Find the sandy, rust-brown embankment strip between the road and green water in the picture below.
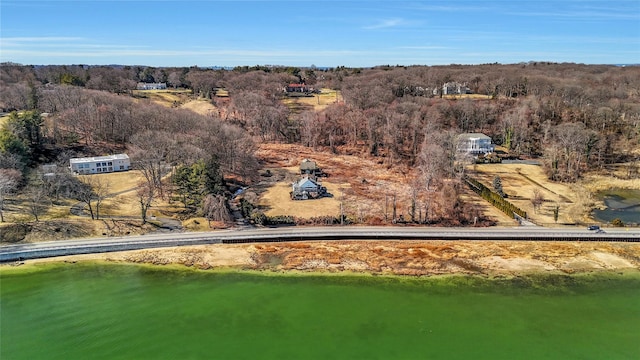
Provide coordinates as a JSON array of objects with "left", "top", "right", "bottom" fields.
[{"left": 15, "top": 241, "right": 640, "bottom": 276}]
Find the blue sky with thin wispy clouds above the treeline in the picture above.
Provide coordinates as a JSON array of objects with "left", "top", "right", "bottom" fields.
[{"left": 0, "top": 0, "right": 640, "bottom": 67}]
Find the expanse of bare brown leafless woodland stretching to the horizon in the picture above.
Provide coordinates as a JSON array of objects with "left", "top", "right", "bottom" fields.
[{"left": 0, "top": 62, "right": 640, "bottom": 226}]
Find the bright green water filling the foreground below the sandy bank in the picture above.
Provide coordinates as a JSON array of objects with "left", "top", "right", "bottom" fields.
[{"left": 0, "top": 263, "right": 640, "bottom": 360}]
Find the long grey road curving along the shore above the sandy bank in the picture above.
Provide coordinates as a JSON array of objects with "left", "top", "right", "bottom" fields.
[{"left": 0, "top": 226, "right": 640, "bottom": 262}]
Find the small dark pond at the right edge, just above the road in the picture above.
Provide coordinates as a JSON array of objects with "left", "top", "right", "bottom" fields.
[{"left": 593, "top": 189, "right": 640, "bottom": 224}]
